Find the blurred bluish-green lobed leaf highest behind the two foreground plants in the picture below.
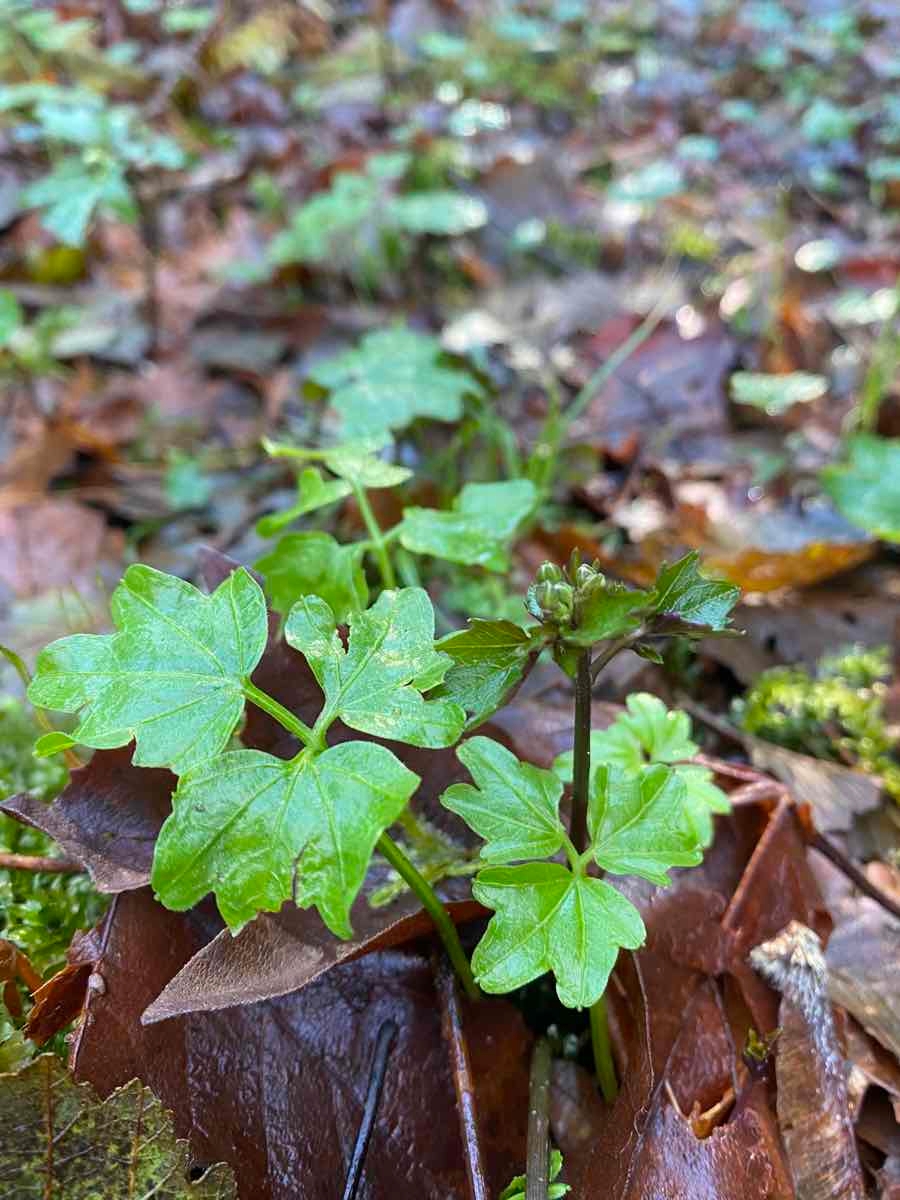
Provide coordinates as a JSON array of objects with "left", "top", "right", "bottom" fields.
[{"left": 310, "top": 329, "right": 481, "bottom": 437}]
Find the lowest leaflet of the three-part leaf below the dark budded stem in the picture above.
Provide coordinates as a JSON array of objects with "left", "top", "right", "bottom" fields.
[{"left": 472, "top": 863, "right": 646, "bottom": 1008}]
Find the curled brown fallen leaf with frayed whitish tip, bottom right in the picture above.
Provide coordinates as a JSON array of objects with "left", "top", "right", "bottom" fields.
[{"left": 750, "top": 920, "right": 865, "bottom": 1200}]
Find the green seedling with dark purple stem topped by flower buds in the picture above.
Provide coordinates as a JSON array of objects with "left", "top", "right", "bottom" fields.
[{"left": 440, "top": 553, "right": 739, "bottom": 1098}]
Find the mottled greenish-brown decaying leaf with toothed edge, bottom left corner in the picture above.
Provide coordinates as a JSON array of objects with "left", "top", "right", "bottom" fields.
[{"left": 0, "top": 1055, "right": 238, "bottom": 1200}]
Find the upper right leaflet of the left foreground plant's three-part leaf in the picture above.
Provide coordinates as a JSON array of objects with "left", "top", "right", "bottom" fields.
[{"left": 284, "top": 588, "right": 466, "bottom": 748}]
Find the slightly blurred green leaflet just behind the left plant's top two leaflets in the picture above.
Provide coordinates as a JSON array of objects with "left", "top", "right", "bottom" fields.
[{"left": 254, "top": 530, "right": 368, "bottom": 622}]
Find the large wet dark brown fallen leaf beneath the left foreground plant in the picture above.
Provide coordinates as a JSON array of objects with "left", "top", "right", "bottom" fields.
[{"left": 73, "top": 889, "right": 530, "bottom": 1200}]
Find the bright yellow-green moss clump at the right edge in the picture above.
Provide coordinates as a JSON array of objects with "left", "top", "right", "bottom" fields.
[{"left": 736, "top": 646, "right": 900, "bottom": 799}]
